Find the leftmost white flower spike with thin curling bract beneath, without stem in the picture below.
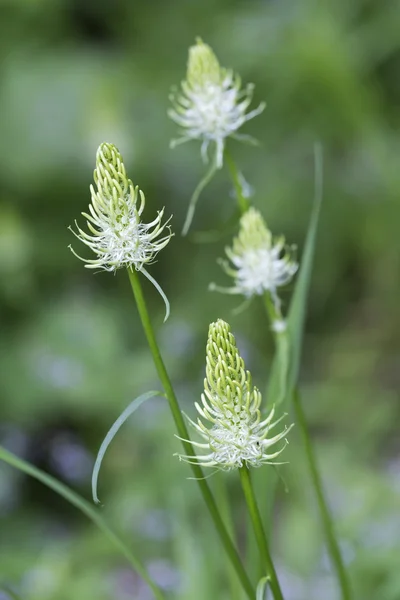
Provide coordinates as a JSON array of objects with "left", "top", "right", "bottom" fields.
[{"left": 69, "top": 143, "right": 173, "bottom": 318}]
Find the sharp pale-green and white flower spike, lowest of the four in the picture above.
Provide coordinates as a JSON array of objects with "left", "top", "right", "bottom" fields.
[{"left": 179, "top": 320, "right": 292, "bottom": 470}]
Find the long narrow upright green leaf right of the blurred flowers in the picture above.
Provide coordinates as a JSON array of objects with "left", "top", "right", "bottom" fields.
[{"left": 267, "top": 144, "right": 323, "bottom": 405}]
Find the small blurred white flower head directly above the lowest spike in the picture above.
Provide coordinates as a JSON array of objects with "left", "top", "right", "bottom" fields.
[{"left": 210, "top": 208, "right": 298, "bottom": 309}]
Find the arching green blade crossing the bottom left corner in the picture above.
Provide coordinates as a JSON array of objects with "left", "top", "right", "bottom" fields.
[{"left": 0, "top": 446, "right": 165, "bottom": 600}]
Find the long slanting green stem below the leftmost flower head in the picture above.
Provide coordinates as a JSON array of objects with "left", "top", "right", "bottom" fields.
[{"left": 128, "top": 269, "right": 255, "bottom": 600}]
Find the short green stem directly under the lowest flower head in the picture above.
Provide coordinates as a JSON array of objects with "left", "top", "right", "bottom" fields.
[{"left": 239, "top": 466, "right": 284, "bottom": 600}]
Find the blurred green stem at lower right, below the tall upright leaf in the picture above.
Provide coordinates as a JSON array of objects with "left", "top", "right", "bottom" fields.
[{"left": 293, "top": 390, "right": 351, "bottom": 600}]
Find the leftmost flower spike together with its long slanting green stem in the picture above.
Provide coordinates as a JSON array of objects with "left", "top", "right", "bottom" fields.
[{"left": 73, "top": 144, "right": 255, "bottom": 600}]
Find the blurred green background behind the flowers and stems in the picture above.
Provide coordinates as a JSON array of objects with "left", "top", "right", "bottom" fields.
[{"left": 0, "top": 0, "right": 400, "bottom": 600}]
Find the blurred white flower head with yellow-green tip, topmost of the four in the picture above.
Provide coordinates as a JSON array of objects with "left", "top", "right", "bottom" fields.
[{"left": 168, "top": 38, "right": 265, "bottom": 168}]
